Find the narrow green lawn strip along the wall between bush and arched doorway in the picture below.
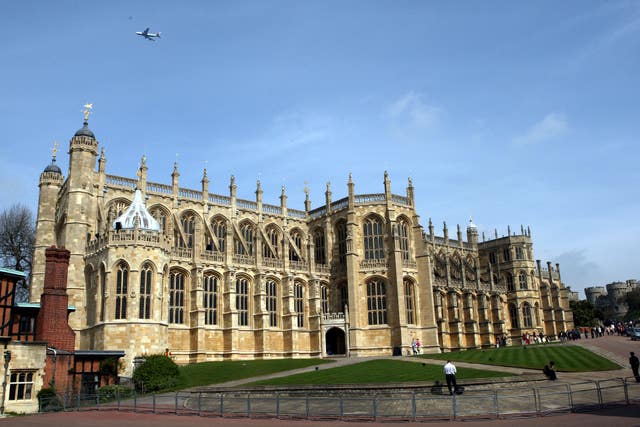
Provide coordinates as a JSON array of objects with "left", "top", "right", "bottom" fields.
[{"left": 176, "top": 359, "right": 333, "bottom": 389}]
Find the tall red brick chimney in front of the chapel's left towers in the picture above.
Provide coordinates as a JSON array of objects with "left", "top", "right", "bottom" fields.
[{"left": 35, "top": 246, "right": 76, "bottom": 351}]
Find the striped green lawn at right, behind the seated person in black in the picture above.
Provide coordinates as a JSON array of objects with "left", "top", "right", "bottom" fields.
[{"left": 420, "top": 344, "right": 620, "bottom": 372}]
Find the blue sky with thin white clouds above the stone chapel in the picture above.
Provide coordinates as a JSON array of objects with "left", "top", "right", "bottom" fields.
[{"left": 0, "top": 0, "right": 640, "bottom": 296}]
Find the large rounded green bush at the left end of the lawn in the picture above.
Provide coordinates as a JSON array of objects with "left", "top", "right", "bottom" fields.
[{"left": 133, "top": 354, "right": 180, "bottom": 392}]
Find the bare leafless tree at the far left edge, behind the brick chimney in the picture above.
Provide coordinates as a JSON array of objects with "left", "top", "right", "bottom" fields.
[{"left": 0, "top": 204, "right": 36, "bottom": 300}]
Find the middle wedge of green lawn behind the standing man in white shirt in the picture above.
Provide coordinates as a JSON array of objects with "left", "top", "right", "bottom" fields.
[{"left": 251, "top": 359, "right": 511, "bottom": 385}]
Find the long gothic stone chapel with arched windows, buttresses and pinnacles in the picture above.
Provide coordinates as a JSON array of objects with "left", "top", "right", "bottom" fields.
[{"left": 31, "top": 123, "right": 572, "bottom": 373}]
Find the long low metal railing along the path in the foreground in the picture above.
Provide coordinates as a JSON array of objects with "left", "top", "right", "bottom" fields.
[{"left": 40, "top": 377, "right": 640, "bottom": 421}]
